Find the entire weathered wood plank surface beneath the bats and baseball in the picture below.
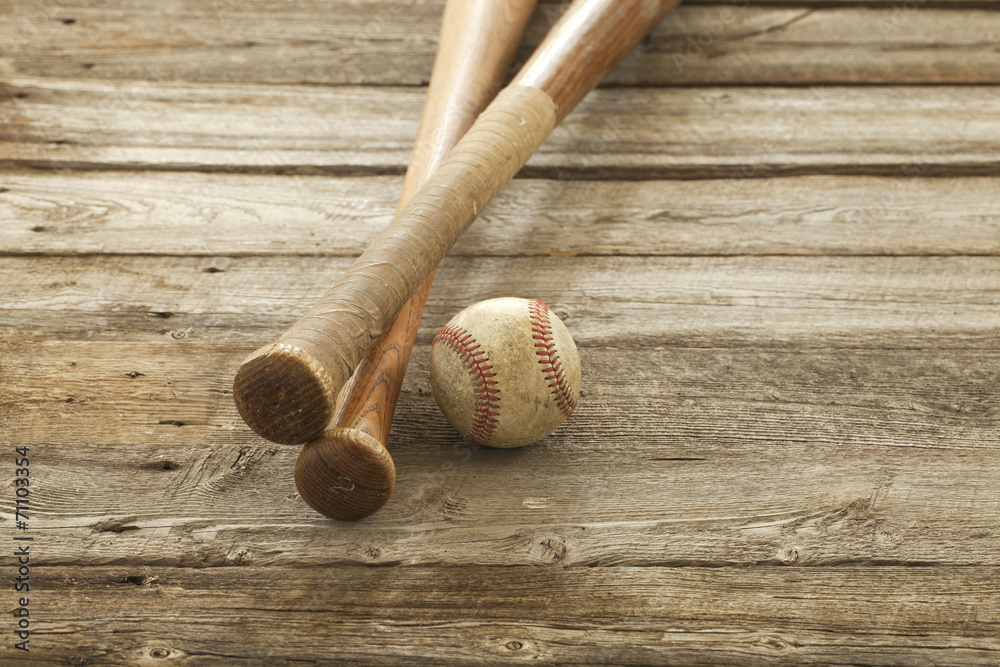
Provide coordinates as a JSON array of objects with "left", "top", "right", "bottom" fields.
[{"left": 0, "top": 0, "right": 1000, "bottom": 665}]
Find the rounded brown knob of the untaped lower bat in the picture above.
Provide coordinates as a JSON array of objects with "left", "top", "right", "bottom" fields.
[{"left": 295, "top": 428, "right": 396, "bottom": 521}]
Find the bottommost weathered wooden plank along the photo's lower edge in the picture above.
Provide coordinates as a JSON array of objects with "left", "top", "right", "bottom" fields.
[{"left": 0, "top": 566, "right": 1000, "bottom": 665}]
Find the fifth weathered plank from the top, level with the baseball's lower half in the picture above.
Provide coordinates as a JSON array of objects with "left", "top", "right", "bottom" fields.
[{"left": 3, "top": 337, "right": 998, "bottom": 451}]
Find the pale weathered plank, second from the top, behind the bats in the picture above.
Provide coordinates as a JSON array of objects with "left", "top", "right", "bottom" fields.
[{"left": 0, "top": 81, "right": 1000, "bottom": 180}]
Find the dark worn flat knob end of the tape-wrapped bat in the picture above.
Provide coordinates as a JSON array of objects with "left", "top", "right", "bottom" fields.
[{"left": 233, "top": 343, "right": 337, "bottom": 445}]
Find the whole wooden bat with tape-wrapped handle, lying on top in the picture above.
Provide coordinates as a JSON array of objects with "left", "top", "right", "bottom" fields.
[{"left": 233, "top": 0, "right": 679, "bottom": 448}]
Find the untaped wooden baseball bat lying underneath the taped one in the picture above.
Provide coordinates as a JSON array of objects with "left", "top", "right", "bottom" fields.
[{"left": 295, "top": 0, "right": 535, "bottom": 520}]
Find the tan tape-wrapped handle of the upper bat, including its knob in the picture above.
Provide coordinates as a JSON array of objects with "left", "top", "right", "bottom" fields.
[{"left": 233, "top": 86, "right": 556, "bottom": 444}]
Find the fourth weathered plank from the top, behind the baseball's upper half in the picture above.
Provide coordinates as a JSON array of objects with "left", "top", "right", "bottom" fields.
[{"left": 0, "top": 256, "right": 1000, "bottom": 353}]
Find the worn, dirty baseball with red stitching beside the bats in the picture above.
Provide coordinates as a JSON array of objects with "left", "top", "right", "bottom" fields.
[{"left": 430, "top": 298, "right": 580, "bottom": 448}]
